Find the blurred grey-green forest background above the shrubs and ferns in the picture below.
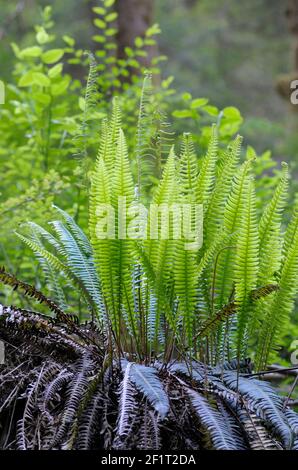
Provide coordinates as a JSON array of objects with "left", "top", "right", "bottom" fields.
[{"left": 0, "top": 0, "right": 298, "bottom": 166}]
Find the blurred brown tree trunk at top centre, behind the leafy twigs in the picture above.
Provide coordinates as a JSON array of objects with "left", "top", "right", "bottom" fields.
[{"left": 116, "top": 0, "right": 156, "bottom": 67}]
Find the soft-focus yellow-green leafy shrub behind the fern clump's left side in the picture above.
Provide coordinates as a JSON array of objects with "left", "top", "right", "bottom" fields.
[{"left": 0, "top": 2, "right": 170, "bottom": 290}]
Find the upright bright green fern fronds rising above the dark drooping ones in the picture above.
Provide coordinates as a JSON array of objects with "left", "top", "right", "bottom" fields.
[{"left": 12, "top": 78, "right": 297, "bottom": 368}]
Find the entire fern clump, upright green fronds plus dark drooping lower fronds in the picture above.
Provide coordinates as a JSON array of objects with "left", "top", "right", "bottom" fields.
[{"left": 0, "top": 77, "right": 298, "bottom": 450}]
